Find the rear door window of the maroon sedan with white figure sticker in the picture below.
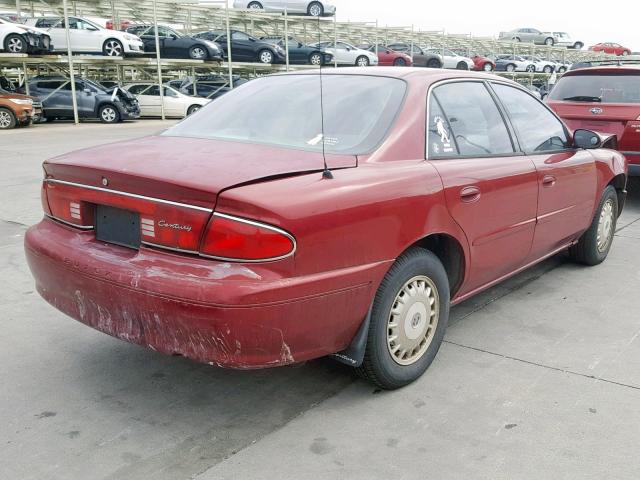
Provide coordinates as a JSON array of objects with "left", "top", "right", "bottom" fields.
[{"left": 429, "top": 82, "right": 514, "bottom": 156}]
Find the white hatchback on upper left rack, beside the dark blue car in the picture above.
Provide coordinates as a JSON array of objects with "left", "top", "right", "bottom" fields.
[{"left": 26, "top": 17, "right": 144, "bottom": 57}]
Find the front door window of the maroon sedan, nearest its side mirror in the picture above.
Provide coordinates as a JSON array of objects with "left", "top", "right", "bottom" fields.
[{"left": 493, "top": 83, "right": 569, "bottom": 153}]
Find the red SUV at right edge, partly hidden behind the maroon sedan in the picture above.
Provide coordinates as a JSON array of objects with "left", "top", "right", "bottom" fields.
[{"left": 547, "top": 65, "right": 640, "bottom": 176}]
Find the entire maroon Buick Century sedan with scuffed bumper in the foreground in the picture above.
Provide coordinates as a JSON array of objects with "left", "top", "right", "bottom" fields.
[{"left": 25, "top": 68, "right": 627, "bottom": 388}]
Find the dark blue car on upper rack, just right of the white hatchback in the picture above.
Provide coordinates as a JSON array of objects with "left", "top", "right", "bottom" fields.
[{"left": 126, "top": 25, "right": 222, "bottom": 61}]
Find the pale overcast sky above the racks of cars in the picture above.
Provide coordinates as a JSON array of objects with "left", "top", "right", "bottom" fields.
[{"left": 328, "top": 0, "right": 640, "bottom": 52}]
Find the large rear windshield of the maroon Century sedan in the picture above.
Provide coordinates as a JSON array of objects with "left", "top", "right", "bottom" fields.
[{"left": 164, "top": 74, "right": 406, "bottom": 155}]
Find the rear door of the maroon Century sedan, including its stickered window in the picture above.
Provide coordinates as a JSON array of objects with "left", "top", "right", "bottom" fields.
[{"left": 427, "top": 80, "right": 538, "bottom": 294}]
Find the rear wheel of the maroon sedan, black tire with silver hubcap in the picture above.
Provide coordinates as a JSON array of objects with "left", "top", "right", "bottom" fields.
[{"left": 357, "top": 248, "right": 449, "bottom": 390}]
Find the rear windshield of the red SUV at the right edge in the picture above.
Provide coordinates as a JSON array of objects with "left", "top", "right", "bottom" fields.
[{"left": 549, "top": 73, "right": 640, "bottom": 103}]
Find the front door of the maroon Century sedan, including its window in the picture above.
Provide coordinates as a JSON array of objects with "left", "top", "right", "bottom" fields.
[{"left": 492, "top": 82, "right": 599, "bottom": 260}]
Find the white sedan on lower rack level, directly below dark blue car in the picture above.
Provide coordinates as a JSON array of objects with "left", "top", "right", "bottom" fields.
[{"left": 124, "top": 83, "right": 211, "bottom": 118}]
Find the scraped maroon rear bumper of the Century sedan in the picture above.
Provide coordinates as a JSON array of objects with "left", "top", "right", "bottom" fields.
[{"left": 25, "top": 219, "right": 390, "bottom": 368}]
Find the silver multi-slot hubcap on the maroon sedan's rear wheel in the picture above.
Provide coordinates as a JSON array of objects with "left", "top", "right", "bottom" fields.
[{"left": 387, "top": 275, "right": 440, "bottom": 365}]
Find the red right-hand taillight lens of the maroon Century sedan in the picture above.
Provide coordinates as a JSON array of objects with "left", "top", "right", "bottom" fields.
[{"left": 200, "top": 213, "right": 296, "bottom": 262}]
